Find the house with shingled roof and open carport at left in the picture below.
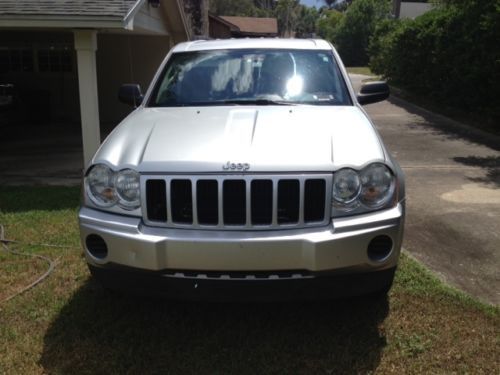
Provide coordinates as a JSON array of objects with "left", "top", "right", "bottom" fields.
[{"left": 0, "top": 0, "right": 191, "bottom": 164}]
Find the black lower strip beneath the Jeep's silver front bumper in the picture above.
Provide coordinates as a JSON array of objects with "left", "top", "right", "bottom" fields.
[{"left": 89, "top": 264, "right": 396, "bottom": 301}]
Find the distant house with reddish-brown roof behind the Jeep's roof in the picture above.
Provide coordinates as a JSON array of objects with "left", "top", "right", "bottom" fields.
[{"left": 208, "top": 14, "right": 278, "bottom": 39}]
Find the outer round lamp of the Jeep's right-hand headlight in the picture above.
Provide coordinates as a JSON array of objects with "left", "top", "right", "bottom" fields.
[{"left": 359, "top": 163, "right": 394, "bottom": 208}]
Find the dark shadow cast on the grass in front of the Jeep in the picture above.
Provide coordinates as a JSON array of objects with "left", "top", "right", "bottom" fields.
[{"left": 40, "top": 280, "right": 389, "bottom": 374}]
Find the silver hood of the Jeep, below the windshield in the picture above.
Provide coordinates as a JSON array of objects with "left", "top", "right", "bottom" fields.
[{"left": 93, "top": 105, "right": 384, "bottom": 173}]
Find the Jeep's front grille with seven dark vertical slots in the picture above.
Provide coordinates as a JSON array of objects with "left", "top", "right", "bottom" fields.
[{"left": 141, "top": 174, "right": 331, "bottom": 230}]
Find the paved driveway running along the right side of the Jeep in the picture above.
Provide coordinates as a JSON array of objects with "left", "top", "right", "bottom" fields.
[{"left": 351, "top": 75, "right": 500, "bottom": 305}]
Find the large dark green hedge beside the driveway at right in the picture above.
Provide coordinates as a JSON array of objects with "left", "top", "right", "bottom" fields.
[{"left": 369, "top": 0, "right": 500, "bottom": 119}]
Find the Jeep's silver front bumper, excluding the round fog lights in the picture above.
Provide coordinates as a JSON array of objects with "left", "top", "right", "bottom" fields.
[{"left": 79, "top": 204, "right": 404, "bottom": 275}]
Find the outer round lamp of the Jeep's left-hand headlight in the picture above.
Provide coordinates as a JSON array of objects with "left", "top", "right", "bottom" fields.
[{"left": 85, "top": 164, "right": 118, "bottom": 207}]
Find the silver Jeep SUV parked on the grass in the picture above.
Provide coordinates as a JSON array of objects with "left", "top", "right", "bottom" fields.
[{"left": 79, "top": 39, "right": 405, "bottom": 299}]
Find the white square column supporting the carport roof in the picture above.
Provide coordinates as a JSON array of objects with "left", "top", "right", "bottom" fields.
[{"left": 73, "top": 30, "right": 101, "bottom": 167}]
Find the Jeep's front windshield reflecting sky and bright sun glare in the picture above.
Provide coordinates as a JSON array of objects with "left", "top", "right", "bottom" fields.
[{"left": 149, "top": 49, "right": 352, "bottom": 107}]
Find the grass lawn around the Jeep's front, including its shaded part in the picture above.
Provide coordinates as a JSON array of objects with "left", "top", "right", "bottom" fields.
[{"left": 0, "top": 187, "right": 500, "bottom": 374}]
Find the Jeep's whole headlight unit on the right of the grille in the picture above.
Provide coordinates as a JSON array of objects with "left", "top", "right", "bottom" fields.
[{"left": 332, "top": 163, "right": 396, "bottom": 216}]
